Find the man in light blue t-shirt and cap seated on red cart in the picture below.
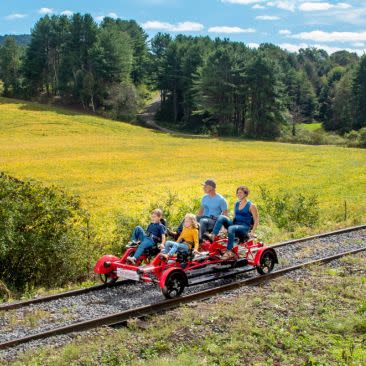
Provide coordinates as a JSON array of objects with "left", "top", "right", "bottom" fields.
[{"left": 197, "top": 179, "right": 228, "bottom": 240}]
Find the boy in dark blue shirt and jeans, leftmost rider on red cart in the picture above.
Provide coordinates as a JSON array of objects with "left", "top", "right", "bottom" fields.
[{"left": 126, "top": 208, "right": 166, "bottom": 264}]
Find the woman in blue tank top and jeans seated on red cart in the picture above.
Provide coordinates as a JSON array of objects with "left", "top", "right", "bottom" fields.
[{"left": 207, "top": 186, "right": 259, "bottom": 259}]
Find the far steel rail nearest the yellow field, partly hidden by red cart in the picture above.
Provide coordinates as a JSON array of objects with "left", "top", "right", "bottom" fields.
[{"left": 0, "top": 225, "right": 366, "bottom": 311}]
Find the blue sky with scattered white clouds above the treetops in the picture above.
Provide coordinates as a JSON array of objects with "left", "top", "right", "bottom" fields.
[{"left": 0, "top": 0, "right": 366, "bottom": 55}]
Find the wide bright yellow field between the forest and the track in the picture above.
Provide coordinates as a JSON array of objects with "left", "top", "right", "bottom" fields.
[{"left": 0, "top": 98, "right": 366, "bottom": 240}]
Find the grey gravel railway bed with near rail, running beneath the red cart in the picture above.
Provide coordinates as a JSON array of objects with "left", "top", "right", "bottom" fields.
[{"left": 0, "top": 225, "right": 366, "bottom": 359}]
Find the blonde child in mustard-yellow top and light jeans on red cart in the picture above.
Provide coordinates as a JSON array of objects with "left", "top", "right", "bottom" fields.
[{"left": 160, "top": 214, "right": 199, "bottom": 259}]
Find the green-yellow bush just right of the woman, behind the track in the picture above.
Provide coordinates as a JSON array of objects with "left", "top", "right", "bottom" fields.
[{"left": 258, "top": 187, "right": 319, "bottom": 232}]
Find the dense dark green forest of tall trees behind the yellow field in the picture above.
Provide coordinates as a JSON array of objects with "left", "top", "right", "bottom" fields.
[{"left": 0, "top": 14, "right": 366, "bottom": 146}]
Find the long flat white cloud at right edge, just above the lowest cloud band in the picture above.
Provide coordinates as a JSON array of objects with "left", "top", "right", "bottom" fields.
[{"left": 288, "top": 30, "right": 366, "bottom": 42}]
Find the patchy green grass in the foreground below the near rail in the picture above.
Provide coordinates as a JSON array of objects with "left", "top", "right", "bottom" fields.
[{"left": 7, "top": 255, "right": 366, "bottom": 366}]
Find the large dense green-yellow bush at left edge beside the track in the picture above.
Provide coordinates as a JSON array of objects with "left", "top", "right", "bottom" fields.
[{"left": 0, "top": 173, "right": 90, "bottom": 291}]
